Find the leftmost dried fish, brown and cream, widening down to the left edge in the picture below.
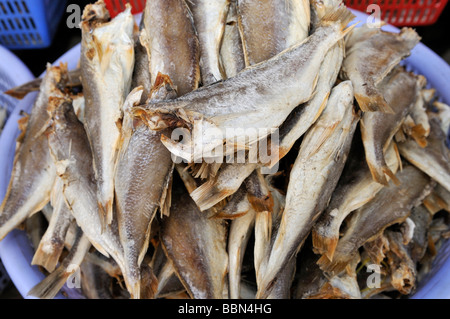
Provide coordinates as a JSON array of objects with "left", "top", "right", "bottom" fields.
[{"left": 0, "top": 65, "right": 67, "bottom": 240}]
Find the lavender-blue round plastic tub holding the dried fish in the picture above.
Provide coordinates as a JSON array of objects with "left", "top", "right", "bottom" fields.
[{"left": 0, "top": 11, "right": 450, "bottom": 299}]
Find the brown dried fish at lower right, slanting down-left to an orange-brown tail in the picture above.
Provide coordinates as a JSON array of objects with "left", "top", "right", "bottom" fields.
[{"left": 318, "top": 165, "right": 433, "bottom": 274}]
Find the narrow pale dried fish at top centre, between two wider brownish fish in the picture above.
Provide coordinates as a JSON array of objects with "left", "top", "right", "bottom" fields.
[{"left": 187, "top": 0, "right": 230, "bottom": 86}]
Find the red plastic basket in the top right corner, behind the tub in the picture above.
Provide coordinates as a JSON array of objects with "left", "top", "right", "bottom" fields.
[{"left": 344, "top": 0, "right": 448, "bottom": 26}]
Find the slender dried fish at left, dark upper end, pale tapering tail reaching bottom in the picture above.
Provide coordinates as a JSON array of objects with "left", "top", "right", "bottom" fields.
[{"left": 47, "top": 102, "right": 140, "bottom": 298}]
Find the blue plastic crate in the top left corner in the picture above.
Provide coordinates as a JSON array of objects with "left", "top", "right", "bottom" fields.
[{"left": 0, "top": 0, "right": 67, "bottom": 50}]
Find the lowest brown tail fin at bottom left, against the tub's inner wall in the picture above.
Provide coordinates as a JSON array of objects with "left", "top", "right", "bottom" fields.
[{"left": 28, "top": 266, "right": 76, "bottom": 299}]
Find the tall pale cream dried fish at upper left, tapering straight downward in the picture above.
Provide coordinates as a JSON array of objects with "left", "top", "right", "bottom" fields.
[{"left": 80, "top": 2, "right": 135, "bottom": 227}]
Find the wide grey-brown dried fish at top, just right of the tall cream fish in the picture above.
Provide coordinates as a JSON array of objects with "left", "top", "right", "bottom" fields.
[{"left": 139, "top": 0, "right": 199, "bottom": 96}]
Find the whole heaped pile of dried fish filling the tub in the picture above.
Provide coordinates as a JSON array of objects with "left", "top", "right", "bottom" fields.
[{"left": 0, "top": 0, "right": 450, "bottom": 299}]
